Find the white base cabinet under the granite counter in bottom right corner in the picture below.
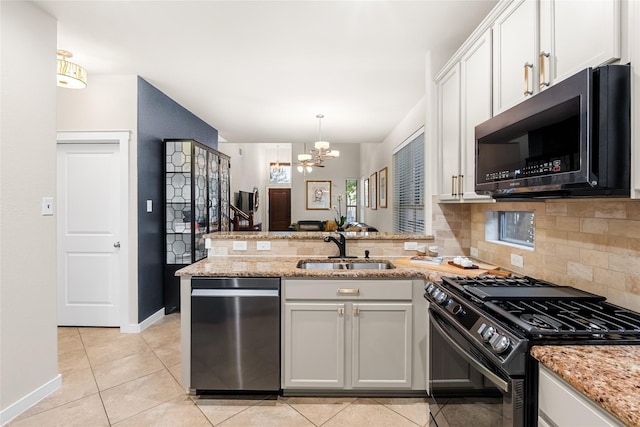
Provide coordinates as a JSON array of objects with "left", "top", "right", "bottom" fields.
[{"left": 538, "top": 365, "right": 624, "bottom": 427}]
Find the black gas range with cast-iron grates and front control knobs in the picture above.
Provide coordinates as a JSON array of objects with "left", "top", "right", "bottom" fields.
[{"left": 425, "top": 275, "right": 640, "bottom": 427}]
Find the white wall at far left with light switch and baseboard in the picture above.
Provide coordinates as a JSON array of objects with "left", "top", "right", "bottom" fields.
[{"left": 0, "top": 1, "right": 61, "bottom": 424}]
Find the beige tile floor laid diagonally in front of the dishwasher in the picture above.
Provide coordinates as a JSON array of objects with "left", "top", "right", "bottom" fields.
[{"left": 9, "top": 314, "right": 430, "bottom": 427}]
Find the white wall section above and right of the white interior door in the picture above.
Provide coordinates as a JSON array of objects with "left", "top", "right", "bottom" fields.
[{"left": 57, "top": 75, "right": 138, "bottom": 325}]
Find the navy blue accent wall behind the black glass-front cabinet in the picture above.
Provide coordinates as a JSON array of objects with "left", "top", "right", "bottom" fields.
[{"left": 138, "top": 77, "right": 218, "bottom": 322}]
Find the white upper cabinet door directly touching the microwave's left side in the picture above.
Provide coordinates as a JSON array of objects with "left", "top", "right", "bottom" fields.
[{"left": 458, "top": 30, "right": 491, "bottom": 200}]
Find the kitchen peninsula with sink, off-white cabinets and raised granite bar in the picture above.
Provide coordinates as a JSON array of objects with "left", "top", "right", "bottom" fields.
[{"left": 177, "top": 232, "right": 444, "bottom": 395}]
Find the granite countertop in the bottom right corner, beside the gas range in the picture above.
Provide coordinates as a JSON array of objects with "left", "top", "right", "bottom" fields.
[{"left": 531, "top": 345, "right": 640, "bottom": 427}]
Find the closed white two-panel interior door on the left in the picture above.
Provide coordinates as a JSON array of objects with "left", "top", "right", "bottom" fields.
[{"left": 57, "top": 143, "right": 122, "bottom": 326}]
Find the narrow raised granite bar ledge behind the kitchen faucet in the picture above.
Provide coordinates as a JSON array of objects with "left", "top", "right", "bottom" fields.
[{"left": 205, "top": 231, "right": 434, "bottom": 240}]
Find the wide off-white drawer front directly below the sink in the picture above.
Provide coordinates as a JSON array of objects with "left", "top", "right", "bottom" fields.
[{"left": 283, "top": 278, "right": 412, "bottom": 301}]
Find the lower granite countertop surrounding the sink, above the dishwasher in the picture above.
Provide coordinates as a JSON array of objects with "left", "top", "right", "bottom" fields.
[{"left": 176, "top": 256, "right": 435, "bottom": 279}]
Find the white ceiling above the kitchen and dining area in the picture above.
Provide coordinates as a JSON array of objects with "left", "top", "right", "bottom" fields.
[{"left": 35, "top": 0, "right": 496, "bottom": 143}]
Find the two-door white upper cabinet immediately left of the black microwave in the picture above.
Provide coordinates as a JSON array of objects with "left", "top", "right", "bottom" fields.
[{"left": 438, "top": 30, "right": 491, "bottom": 201}]
